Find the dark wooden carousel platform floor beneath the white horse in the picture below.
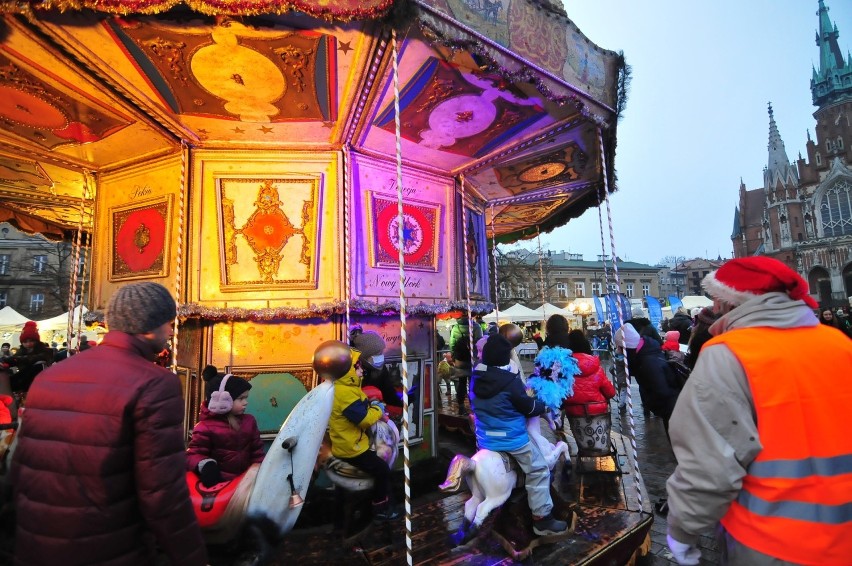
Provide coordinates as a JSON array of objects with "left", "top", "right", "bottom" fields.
[{"left": 269, "top": 422, "right": 653, "bottom": 566}]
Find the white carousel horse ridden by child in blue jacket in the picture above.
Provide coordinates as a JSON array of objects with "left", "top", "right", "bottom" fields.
[{"left": 439, "top": 417, "right": 571, "bottom": 542}]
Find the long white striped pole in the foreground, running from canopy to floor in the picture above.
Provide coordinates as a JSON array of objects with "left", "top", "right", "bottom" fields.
[{"left": 391, "top": 28, "right": 414, "bottom": 566}]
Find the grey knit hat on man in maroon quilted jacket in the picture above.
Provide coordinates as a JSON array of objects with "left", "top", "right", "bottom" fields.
[{"left": 106, "top": 281, "right": 177, "bottom": 334}]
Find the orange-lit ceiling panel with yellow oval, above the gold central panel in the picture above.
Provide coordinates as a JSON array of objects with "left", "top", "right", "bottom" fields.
[{"left": 31, "top": 13, "right": 373, "bottom": 147}]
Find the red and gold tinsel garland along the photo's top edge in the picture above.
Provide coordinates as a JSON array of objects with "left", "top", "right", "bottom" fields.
[{"left": 0, "top": 0, "right": 394, "bottom": 21}]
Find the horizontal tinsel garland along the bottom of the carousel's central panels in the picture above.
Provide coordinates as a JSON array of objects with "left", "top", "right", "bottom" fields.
[{"left": 84, "top": 299, "right": 494, "bottom": 324}]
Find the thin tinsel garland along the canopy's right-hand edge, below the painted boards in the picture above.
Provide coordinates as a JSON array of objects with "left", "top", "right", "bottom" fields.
[{"left": 418, "top": 18, "right": 607, "bottom": 127}]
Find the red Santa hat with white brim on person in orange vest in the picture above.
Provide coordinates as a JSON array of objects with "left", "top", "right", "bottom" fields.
[{"left": 701, "top": 256, "right": 818, "bottom": 308}]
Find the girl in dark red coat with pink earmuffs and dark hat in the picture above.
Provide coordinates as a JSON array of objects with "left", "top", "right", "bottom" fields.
[{"left": 186, "top": 366, "right": 264, "bottom": 487}]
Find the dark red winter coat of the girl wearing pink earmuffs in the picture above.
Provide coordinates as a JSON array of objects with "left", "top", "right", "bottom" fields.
[{"left": 186, "top": 405, "right": 263, "bottom": 481}]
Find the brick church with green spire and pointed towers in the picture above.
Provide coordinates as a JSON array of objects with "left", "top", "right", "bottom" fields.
[{"left": 731, "top": 0, "right": 852, "bottom": 306}]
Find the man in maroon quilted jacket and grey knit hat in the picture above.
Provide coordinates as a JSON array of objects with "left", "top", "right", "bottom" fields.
[{"left": 10, "top": 282, "right": 207, "bottom": 566}]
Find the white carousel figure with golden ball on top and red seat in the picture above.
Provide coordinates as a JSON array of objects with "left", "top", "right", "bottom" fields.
[{"left": 187, "top": 340, "right": 352, "bottom": 543}]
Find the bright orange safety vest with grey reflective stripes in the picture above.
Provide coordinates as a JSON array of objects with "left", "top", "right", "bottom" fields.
[{"left": 708, "top": 325, "right": 852, "bottom": 566}]
